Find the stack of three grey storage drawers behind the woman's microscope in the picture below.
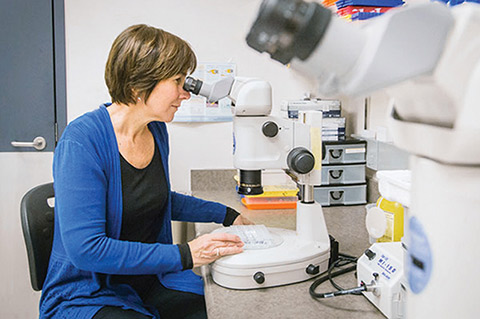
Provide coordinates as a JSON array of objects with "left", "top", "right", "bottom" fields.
[{"left": 314, "top": 139, "right": 367, "bottom": 206}]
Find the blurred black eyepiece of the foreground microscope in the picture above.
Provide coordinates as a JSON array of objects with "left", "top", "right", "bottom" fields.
[{"left": 246, "top": 0, "right": 332, "bottom": 64}]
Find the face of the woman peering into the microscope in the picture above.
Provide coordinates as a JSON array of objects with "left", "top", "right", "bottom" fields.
[{"left": 145, "top": 74, "right": 190, "bottom": 122}]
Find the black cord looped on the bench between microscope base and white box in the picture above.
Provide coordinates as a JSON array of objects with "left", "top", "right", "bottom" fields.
[{"left": 309, "top": 253, "right": 368, "bottom": 299}]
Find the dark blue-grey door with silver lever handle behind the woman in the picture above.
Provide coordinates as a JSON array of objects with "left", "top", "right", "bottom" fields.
[{"left": 0, "top": 0, "right": 65, "bottom": 152}]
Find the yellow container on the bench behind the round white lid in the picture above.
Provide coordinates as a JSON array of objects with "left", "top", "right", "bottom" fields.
[{"left": 377, "top": 196, "right": 404, "bottom": 242}]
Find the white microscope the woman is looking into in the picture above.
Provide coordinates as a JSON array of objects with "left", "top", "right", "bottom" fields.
[{"left": 184, "top": 77, "right": 330, "bottom": 289}]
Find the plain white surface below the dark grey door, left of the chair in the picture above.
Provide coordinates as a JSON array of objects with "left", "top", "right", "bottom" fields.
[{"left": 0, "top": 152, "right": 53, "bottom": 319}]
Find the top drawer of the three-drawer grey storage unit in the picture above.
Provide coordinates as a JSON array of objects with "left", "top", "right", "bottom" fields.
[{"left": 322, "top": 140, "right": 367, "bottom": 165}]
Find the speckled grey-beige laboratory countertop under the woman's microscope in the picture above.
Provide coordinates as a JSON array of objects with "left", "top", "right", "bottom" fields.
[{"left": 192, "top": 172, "right": 385, "bottom": 319}]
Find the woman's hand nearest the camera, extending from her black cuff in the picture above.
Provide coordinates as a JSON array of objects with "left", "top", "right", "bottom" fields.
[{"left": 188, "top": 232, "right": 244, "bottom": 267}]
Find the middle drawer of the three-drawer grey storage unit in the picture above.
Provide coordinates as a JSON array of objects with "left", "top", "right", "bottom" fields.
[{"left": 322, "top": 164, "right": 366, "bottom": 185}]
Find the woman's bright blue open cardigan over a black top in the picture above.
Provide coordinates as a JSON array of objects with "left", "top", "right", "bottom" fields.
[{"left": 40, "top": 105, "right": 226, "bottom": 318}]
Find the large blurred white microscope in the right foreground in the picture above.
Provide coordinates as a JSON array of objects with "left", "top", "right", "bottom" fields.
[{"left": 247, "top": 0, "right": 480, "bottom": 318}]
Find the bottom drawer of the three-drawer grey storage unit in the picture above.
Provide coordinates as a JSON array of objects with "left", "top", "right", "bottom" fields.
[{"left": 314, "top": 184, "right": 367, "bottom": 206}]
